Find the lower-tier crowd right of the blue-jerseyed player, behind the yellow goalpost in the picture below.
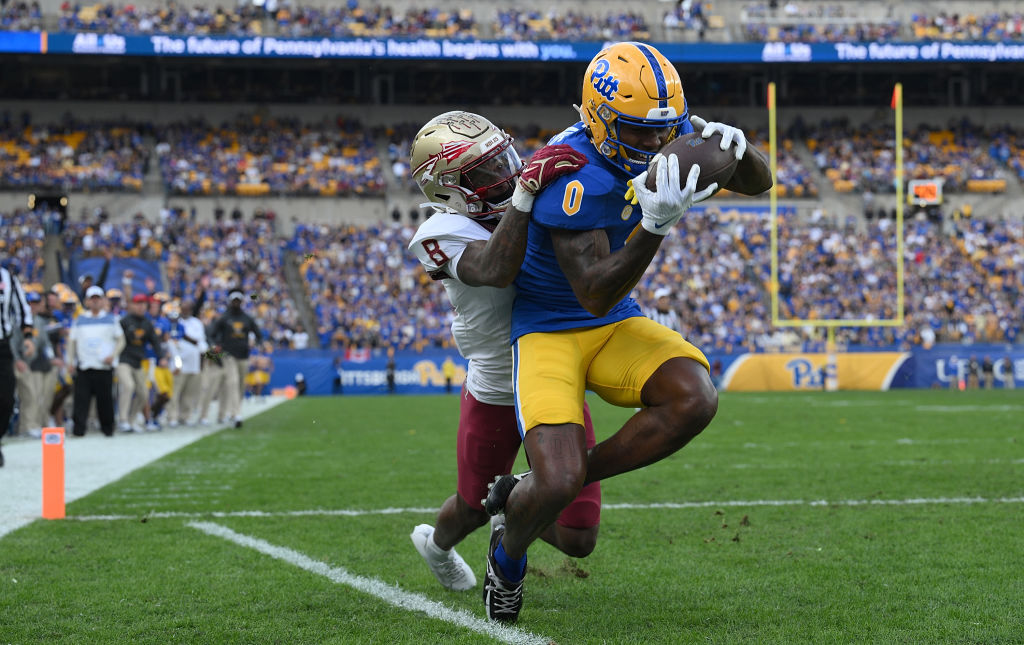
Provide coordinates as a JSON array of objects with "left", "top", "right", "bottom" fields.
[{"left": 651, "top": 208, "right": 1024, "bottom": 352}]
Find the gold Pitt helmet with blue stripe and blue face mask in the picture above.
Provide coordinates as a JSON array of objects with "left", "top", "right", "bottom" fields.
[{"left": 580, "top": 42, "right": 688, "bottom": 175}]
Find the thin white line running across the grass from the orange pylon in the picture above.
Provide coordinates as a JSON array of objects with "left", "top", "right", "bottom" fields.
[{"left": 68, "top": 497, "right": 1024, "bottom": 522}]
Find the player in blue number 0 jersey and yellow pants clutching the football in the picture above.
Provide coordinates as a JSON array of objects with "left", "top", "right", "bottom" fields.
[{"left": 483, "top": 42, "right": 770, "bottom": 621}]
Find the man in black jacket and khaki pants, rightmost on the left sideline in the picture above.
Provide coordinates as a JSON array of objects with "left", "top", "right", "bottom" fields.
[{"left": 210, "top": 291, "right": 263, "bottom": 428}]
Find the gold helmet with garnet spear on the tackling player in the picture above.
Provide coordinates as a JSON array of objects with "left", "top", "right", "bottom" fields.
[{"left": 410, "top": 112, "right": 522, "bottom": 218}]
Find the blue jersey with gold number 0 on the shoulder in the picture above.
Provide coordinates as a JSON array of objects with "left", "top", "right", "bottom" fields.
[{"left": 512, "top": 122, "right": 692, "bottom": 343}]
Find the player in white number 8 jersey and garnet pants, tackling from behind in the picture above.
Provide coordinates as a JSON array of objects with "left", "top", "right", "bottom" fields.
[{"left": 409, "top": 112, "right": 601, "bottom": 591}]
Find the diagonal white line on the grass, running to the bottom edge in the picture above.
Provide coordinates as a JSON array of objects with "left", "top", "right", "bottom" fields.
[{"left": 188, "top": 522, "right": 551, "bottom": 645}]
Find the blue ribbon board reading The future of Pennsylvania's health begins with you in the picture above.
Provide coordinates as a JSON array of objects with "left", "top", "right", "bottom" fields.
[{"left": 0, "top": 32, "right": 1024, "bottom": 63}]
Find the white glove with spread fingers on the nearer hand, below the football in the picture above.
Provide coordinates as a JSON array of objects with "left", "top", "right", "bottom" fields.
[{"left": 627, "top": 155, "right": 718, "bottom": 235}]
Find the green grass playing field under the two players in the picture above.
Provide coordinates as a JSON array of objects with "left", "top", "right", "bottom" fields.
[{"left": 0, "top": 391, "right": 1024, "bottom": 645}]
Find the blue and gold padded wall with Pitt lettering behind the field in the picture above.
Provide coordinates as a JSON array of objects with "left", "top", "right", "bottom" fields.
[{"left": 270, "top": 345, "right": 1024, "bottom": 395}]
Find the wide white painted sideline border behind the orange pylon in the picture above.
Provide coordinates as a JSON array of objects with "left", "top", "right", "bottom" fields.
[{"left": 0, "top": 396, "right": 286, "bottom": 538}]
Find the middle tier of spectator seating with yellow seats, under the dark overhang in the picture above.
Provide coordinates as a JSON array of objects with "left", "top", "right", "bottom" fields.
[{"left": 14, "top": 114, "right": 1024, "bottom": 198}]
